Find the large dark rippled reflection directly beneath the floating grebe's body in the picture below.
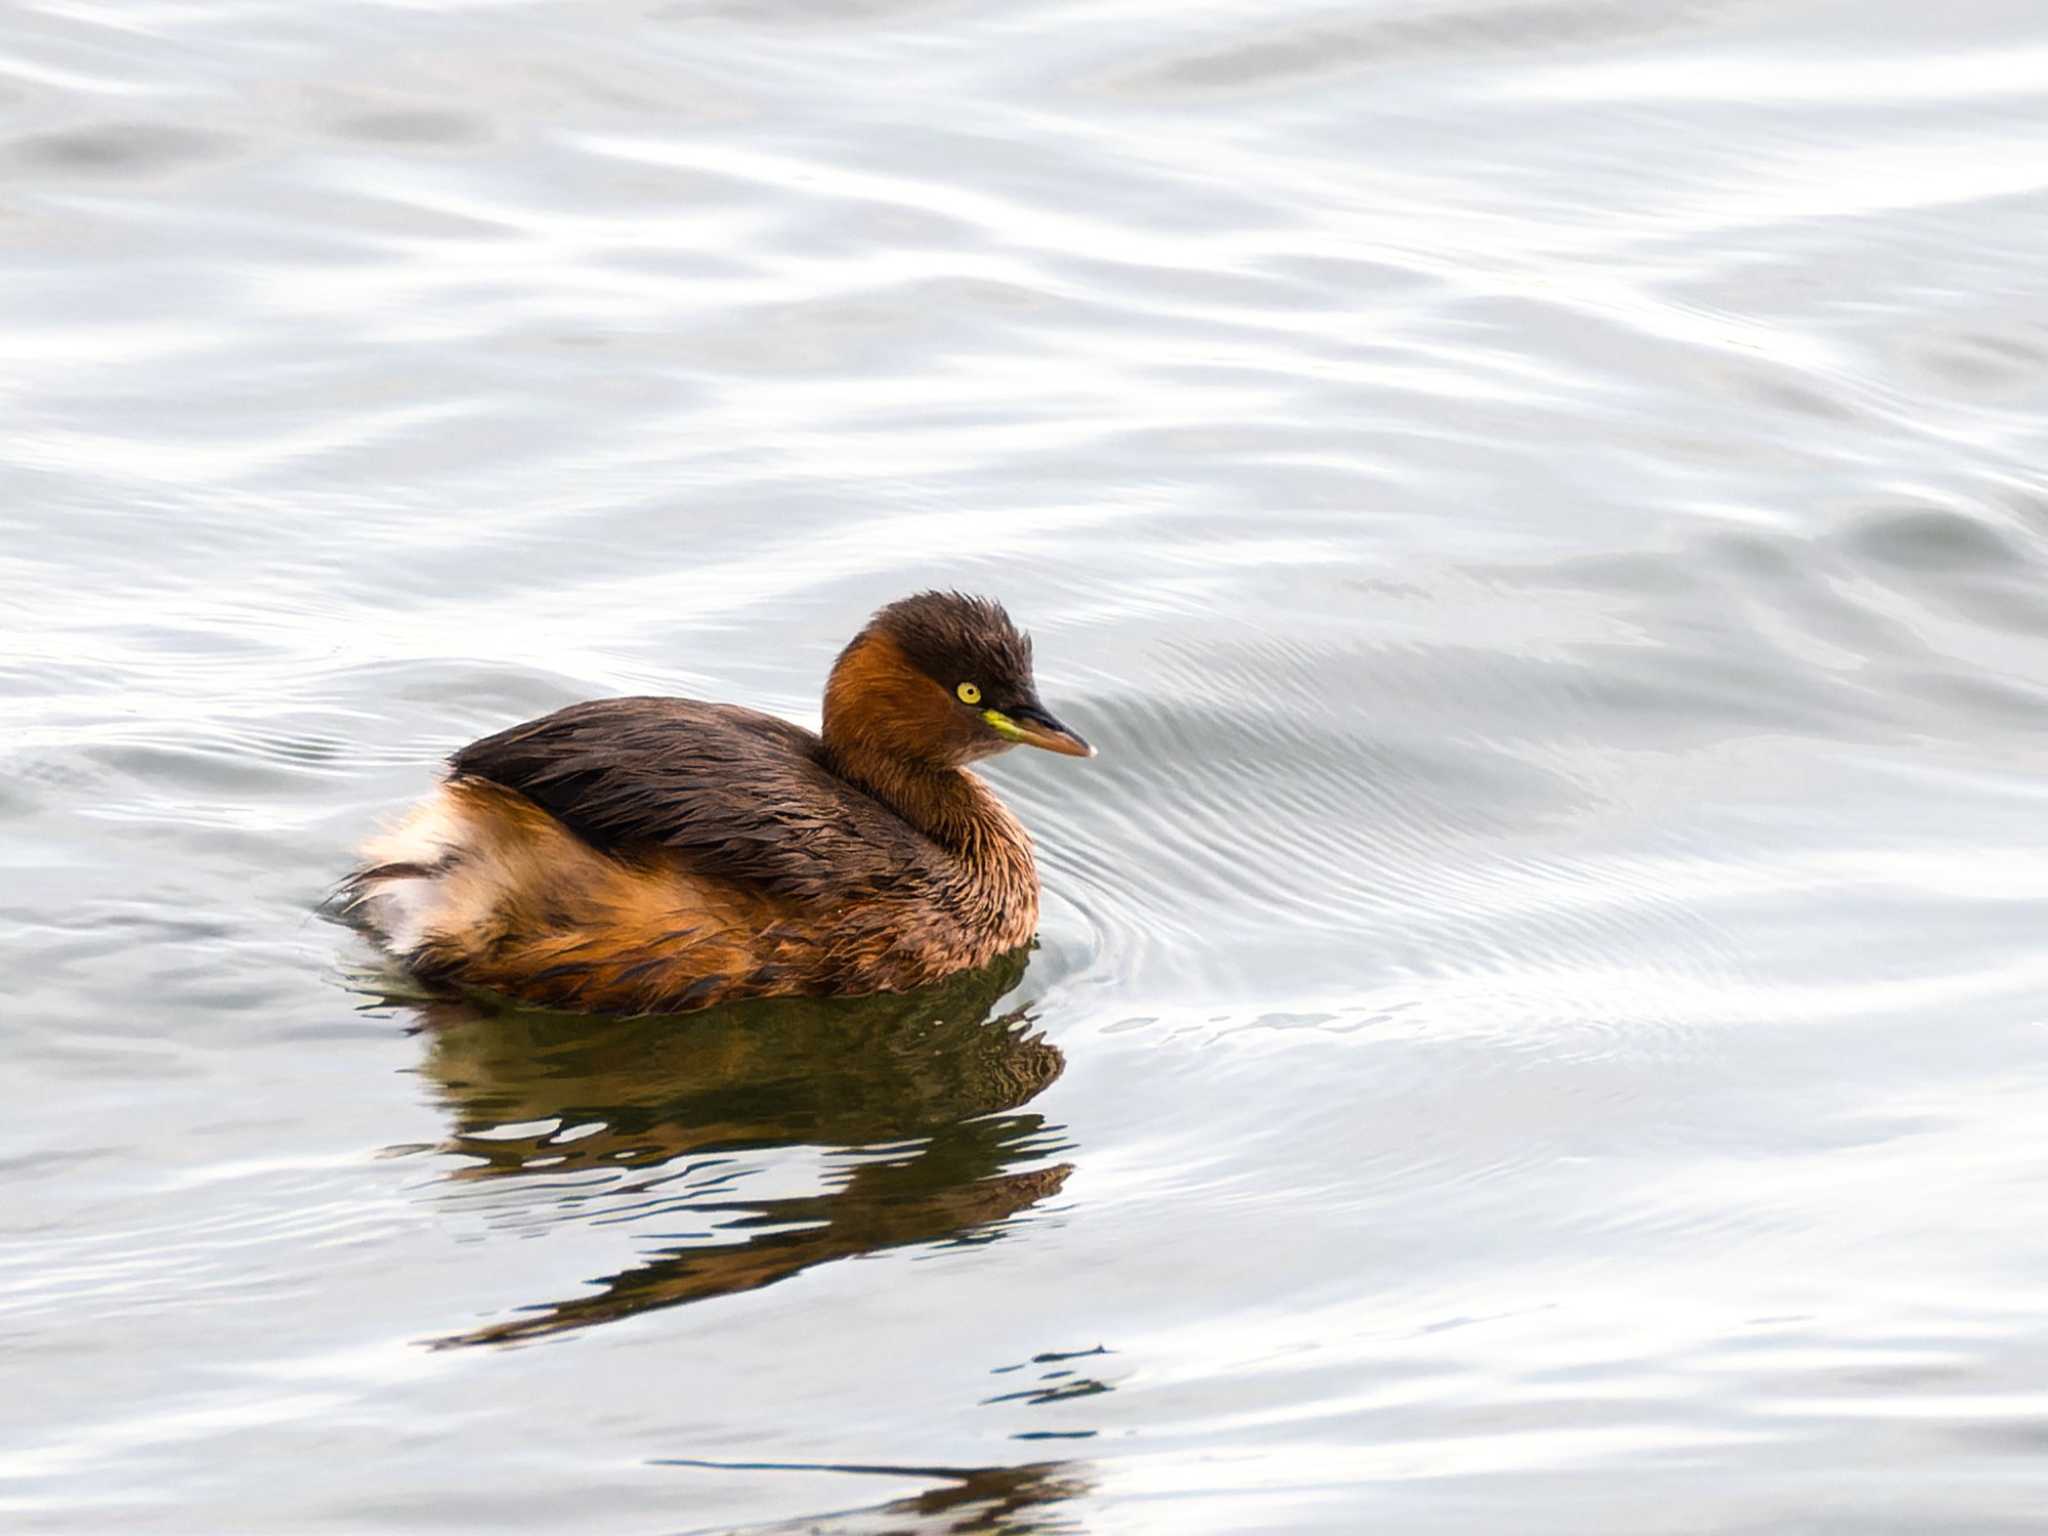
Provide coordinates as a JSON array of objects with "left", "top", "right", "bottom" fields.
[{"left": 395, "top": 954, "right": 1069, "bottom": 1346}]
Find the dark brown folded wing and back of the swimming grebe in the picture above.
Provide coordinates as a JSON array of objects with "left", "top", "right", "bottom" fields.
[{"left": 449, "top": 698, "right": 938, "bottom": 901}]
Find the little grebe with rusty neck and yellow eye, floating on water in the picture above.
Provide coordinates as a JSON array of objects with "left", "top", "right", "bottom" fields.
[{"left": 340, "top": 592, "right": 1094, "bottom": 1014}]
